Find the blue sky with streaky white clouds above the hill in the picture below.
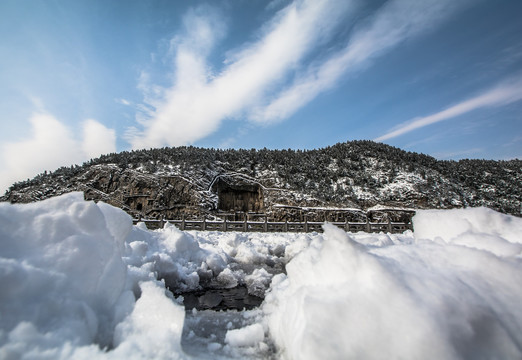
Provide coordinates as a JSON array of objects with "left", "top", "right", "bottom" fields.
[{"left": 0, "top": 0, "right": 522, "bottom": 189}]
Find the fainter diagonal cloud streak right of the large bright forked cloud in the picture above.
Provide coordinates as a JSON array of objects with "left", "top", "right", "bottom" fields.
[{"left": 250, "top": 0, "right": 465, "bottom": 123}]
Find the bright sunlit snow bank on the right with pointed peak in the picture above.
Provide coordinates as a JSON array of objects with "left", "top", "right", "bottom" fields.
[{"left": 263, "top": 214, "right": 522, "bottom": 359}]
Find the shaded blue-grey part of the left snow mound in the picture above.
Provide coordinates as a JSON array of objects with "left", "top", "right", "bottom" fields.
[{"left": 0, "top": 193, "right": 132, "bottom": 346}]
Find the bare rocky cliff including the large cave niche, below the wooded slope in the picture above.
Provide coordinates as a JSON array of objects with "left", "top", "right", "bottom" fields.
[{"left": 2, "top": 164, "right": 398, "bottom": 222}]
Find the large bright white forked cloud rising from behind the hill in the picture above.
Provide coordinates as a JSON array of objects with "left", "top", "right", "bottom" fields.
[{"left": 129, "top": 0, "right": 351, "bottom": 148}]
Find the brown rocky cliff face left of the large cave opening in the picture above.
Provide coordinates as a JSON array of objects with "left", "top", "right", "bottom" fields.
[{"left": 4, "top": 165, "right": 210, "bottom": 218}]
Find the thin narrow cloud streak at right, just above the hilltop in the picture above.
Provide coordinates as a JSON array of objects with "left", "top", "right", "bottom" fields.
[{"left": 374, "top": 77, "right": 522, "bottom": 141}]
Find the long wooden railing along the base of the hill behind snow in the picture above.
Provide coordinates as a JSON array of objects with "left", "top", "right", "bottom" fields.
[{"left": 133, "top": 219, "right": 413, "bottom": 233}]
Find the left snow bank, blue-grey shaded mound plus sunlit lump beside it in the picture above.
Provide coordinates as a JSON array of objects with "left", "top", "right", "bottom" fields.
[{"left": 0, "top": 193, "right": 184, "bottom": 359}]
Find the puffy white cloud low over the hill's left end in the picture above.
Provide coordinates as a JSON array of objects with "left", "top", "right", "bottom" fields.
[{"left": 0, "top": 113, "right": 116, "bottom": 191}]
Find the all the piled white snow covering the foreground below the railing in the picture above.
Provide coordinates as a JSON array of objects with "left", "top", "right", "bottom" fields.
[{"left": 0, "top": 193, "right": 522, "bottom": 359}]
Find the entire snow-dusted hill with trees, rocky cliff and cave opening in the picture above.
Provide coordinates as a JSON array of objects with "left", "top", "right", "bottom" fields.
[{"left": 0, "top": 141, "right": 522, "bottom": 221}]
